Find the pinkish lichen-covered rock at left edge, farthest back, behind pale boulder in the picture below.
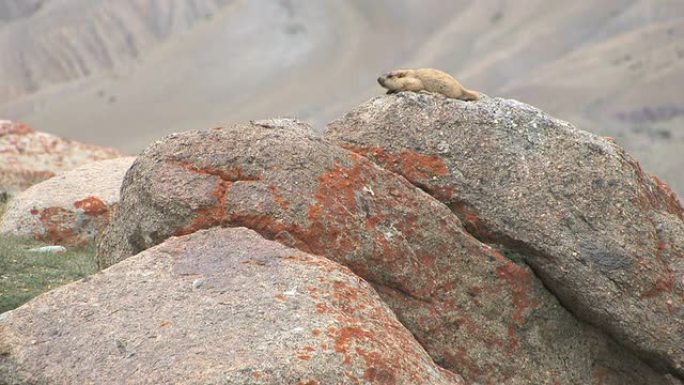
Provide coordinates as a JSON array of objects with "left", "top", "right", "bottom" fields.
[{"left": 0, "top": 120, "right": 125, "bottom": 204}]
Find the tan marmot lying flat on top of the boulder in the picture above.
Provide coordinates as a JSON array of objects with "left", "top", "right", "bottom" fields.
[{"left": 378, "top": 68, "right": 480, "bottom": 100}]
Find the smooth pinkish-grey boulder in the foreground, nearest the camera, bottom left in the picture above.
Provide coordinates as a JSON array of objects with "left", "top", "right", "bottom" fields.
[{"left": 0, "top": 228, "right": 464, "bottom": 385}]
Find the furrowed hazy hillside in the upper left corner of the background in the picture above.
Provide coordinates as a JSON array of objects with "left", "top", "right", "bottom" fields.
[{"left": 0, "top": 0, "right": 228, "bottom": 103}]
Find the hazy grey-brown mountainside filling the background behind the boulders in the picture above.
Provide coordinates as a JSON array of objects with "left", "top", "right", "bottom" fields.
[{"left": 0, "top": 0, "right": 684, "bottom": 196}]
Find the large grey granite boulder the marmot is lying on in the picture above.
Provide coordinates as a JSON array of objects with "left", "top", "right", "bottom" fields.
[{"left": 326, "top": 93, "right": 684, "bottom": 379}]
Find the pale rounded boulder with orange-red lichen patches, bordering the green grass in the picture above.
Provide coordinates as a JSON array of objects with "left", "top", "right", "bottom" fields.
[{"left": 0, "top": 157, "right": 135, "bottom": 245}]
